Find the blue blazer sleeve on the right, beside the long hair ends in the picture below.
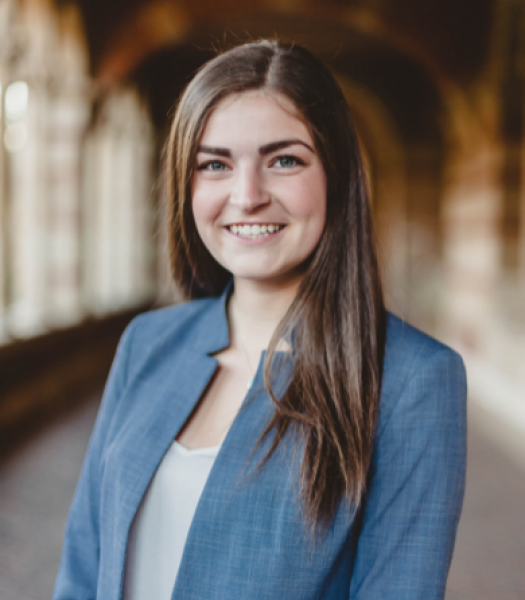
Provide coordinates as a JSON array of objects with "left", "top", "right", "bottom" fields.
[{"left": 350, "top": 347, "right": 467, "bottom": 600}]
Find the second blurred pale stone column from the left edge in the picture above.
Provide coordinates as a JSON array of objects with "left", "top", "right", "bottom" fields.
[{"left": 46, "top": 6, "right": 90, "bottom": 327}]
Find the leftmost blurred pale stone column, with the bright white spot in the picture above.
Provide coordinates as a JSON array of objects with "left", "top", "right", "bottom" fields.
[{"left": 4, "top": 2, "right": 54, "bottom": 337}]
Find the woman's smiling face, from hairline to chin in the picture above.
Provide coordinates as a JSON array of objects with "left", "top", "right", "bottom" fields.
[{"left": 192, "top": 92, "right": 326, "bottom": 290}]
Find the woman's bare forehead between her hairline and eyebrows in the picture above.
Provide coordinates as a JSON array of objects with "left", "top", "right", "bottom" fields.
[{"left": 201, "top": 90, "right": 312, "bottom": 141}]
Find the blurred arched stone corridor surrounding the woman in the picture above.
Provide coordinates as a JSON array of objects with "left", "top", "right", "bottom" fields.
[{"left": 0, "top": 0, "right": 525, "bottom": 600}]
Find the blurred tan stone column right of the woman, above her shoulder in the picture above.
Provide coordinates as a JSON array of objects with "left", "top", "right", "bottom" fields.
[{"left": 441, "top": 131, "right": 501, "bottom": 350}]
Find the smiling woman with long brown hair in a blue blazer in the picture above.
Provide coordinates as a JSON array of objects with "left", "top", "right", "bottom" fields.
[{"left": 54, "top": 41, "right": 466, "bottom": 600}]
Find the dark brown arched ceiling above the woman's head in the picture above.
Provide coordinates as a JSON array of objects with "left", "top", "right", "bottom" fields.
[{"left": 64, "top": 0, "right": 495, "bottom": 145}]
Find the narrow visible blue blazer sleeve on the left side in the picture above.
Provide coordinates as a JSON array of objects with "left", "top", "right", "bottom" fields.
[{"left": 53, "top": 320, "right": 136, "bottom": 600}]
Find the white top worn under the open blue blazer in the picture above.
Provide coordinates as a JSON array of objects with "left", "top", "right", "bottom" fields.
[{"left": 123, "top": 441, "right": 220, "bottom": 600}]
